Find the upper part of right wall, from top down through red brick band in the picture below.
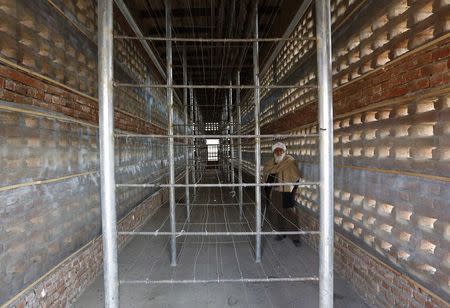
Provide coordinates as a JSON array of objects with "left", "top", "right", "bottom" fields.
[{"left": 243, "top": 0, "right": 450, "bottom": 131}]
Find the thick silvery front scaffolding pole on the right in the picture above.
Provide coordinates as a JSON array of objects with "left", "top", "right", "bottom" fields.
[{"left": 316, "top": 0, "right": 334, "bottom": 308}]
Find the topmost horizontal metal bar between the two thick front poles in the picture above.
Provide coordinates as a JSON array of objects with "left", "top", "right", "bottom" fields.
[{"left": 114, "top": 35, "right": 316, "bottom": 43}]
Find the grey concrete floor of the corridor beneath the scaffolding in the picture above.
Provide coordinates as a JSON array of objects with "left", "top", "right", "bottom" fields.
[{"left": 74, "top": 171, "right": 368, "bottom": 308}]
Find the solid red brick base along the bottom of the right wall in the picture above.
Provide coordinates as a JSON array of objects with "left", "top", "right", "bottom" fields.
[{"left": 296, "top": 208, "right": 448, "bottom": 308}]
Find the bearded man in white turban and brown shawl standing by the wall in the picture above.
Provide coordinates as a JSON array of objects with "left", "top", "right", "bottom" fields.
[{"left": 263, "top": 142, "right": 301, "bottom": 247}]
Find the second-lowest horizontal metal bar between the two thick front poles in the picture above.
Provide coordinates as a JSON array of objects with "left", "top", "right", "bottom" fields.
[{"left": 117, "top": 231, "right": 320, "bottom": 237}]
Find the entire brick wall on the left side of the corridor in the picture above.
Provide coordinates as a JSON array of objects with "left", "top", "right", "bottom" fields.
[{"left": 0, "top": 0, "right": 188, "bottom": 306}]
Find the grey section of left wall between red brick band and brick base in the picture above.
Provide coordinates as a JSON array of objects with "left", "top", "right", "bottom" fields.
[{"left": 0, "top": 101, "right": 184, "bottom": 300}]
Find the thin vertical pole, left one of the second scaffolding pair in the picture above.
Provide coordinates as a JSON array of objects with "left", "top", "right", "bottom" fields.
[{"left": 164, "top": 0, "right": 177, "bottom": 266}]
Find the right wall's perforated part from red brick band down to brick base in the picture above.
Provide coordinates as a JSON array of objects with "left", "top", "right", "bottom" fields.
[{"left": 274, "top": 31, "right": 450, "bottom": 304}]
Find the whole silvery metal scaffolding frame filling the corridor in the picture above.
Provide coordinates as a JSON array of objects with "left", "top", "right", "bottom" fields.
[{"left": 98, "top": 0, "right": 334, "bottom": 307}]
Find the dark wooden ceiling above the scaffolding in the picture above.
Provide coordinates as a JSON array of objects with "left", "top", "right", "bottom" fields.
[{"left": 127, "top": 0, "right": 302, "bottom": 122}]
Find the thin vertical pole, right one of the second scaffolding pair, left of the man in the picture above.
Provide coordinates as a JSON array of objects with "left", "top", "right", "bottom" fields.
[{"left": 253, "top": 1, "right": 261, "bottom": 262}]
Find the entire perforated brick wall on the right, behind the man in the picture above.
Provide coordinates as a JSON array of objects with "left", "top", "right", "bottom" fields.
[{"left": 243, "top": 0, "right": 450, "bottom": 307}]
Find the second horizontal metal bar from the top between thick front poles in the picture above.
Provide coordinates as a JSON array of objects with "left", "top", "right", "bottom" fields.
[{"left": 114, "top": 82, "right": 317, "bottom": 89}]
